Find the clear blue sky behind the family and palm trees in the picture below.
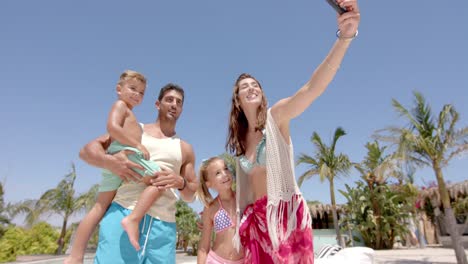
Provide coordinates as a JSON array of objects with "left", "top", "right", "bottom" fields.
[{"left": 0, "top": 0, "right": 468, "bottom": 225}]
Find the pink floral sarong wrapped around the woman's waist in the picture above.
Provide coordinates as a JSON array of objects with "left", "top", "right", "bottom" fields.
[{"left": 239, "top": 196, "right": 314, "bottom": 264}]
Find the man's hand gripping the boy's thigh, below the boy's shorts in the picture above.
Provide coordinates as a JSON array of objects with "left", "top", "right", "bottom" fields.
[{"left": 107, "top": 151, "right": 144, "bottom": 182}]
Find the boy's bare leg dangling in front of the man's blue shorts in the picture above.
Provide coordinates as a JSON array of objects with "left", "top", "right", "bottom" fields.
[{"left": 121, "top": 186, "right": 160, "bottom": 251}]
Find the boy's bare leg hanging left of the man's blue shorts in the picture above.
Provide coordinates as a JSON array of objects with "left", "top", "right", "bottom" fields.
[{"left": 63, "top": 191, "right": 116, "bottom": 264}]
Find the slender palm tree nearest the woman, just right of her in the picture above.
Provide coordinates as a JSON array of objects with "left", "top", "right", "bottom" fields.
[{"left": 297, "top": 127, "right": 351, "bottom": 247}]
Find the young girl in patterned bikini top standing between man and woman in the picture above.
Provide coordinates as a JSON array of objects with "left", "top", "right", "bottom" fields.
[{"left": 197, "top": 157, "right": 244, "bottom": 264}]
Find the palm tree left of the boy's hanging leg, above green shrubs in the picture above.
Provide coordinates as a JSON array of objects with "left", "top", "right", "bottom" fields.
[{"left": 17, "top": 164, "right": 97, "bottom": 254}]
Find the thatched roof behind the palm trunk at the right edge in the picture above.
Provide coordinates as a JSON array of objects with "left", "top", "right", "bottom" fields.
[{"left": 420, "top": 180, "right": 468, "bottom": 207}]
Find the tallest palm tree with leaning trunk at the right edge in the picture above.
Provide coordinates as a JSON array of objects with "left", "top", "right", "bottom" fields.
[{"left": 377, "top": 92, "right": 468, "bottom": 264}]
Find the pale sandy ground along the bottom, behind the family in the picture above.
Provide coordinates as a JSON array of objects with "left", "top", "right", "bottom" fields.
[{"left": 11, "top": 247, "right": 468, "bottom": 264}]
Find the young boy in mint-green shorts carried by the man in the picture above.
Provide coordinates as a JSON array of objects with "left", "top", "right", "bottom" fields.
[{"left": 64, "top": 70, "right": 160, "bottom": 264}]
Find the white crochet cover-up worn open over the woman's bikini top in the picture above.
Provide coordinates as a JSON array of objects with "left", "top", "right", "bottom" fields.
[{"left": 233, "top": 109, "right": 312, "bottom": 249}]
